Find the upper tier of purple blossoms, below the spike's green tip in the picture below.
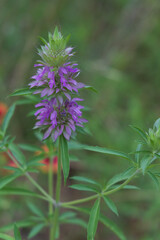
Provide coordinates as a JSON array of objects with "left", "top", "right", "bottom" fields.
[{"left": 29, "top": 62, "right": 84, "bottom": 99}]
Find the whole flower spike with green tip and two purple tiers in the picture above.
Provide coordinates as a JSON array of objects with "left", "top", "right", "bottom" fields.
[{"left": 29, "top": 28, "right": 87, "bottom": 141}]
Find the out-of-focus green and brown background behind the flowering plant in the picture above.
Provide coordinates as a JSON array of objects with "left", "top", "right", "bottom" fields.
[{"left": 0, "top": 0, "right": 160, "bottom": 240}]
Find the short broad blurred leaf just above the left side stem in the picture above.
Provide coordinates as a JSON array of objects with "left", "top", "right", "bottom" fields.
[{"left": 9, "top": 143, "right": 26, "bottom": 166}]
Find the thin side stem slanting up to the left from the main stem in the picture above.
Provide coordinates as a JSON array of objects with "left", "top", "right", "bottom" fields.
[{"left": 7, "top": 151, "right": 56, "bottom": 205}]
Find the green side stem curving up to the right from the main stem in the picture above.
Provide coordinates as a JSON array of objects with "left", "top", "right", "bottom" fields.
[{"left": 60, "top": 170, "right": 139, "bottom": 207}]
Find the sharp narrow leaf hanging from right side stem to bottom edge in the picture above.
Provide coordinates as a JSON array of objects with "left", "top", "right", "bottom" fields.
[{"left": 87, "top": 198, "right": 100, "bottom": 240}]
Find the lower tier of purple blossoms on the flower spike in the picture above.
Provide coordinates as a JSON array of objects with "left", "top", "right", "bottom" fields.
[{"left": 35, "top": 97, "right": 87, "bottom": 141}]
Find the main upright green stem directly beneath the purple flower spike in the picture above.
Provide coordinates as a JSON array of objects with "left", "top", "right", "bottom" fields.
[{"left": 52, "top": 137, "right": 61, "bottom": 240}]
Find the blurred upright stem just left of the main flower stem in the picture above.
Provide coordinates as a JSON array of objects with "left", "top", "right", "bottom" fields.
[{"left": 48, "top": 157, "right": 53, "bottom": 240}]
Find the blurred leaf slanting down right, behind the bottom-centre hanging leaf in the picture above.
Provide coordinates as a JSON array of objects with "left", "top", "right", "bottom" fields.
[{"left": 70, "top": 207, "right": 127, "bottom": 240}]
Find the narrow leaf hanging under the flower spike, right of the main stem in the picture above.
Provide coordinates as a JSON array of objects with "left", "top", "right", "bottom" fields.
[{"left": 60, "top": 135, "right": 70, "bottom": 183}]
